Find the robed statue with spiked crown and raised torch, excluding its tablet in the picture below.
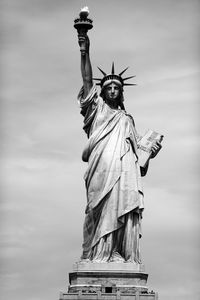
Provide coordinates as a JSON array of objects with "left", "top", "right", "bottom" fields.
[{"left": 74, "top": 9, "right": 161, "bottom": 264}]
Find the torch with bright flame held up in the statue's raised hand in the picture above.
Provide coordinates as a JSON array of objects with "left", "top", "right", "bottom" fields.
[{"left": 74, "top": 6, "right": 93, "bottom": 54}]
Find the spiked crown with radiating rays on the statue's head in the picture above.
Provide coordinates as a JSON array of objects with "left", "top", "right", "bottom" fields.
[{"left": 93, "top": 62, "right": 136, "bottom": 88}]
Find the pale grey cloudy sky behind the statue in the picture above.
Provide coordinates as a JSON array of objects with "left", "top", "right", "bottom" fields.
[{"left": 0, "top": 0, "right": 200, "bottom": 300}]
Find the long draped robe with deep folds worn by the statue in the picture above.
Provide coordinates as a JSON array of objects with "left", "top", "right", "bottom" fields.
[{"left": 78, "top": 85, "right": 144, "bottom": 262}]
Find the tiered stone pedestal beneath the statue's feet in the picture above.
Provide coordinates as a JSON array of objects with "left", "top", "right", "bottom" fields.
[{"left": 60, "top": 262, "right": 158, "bottom": 300}]
